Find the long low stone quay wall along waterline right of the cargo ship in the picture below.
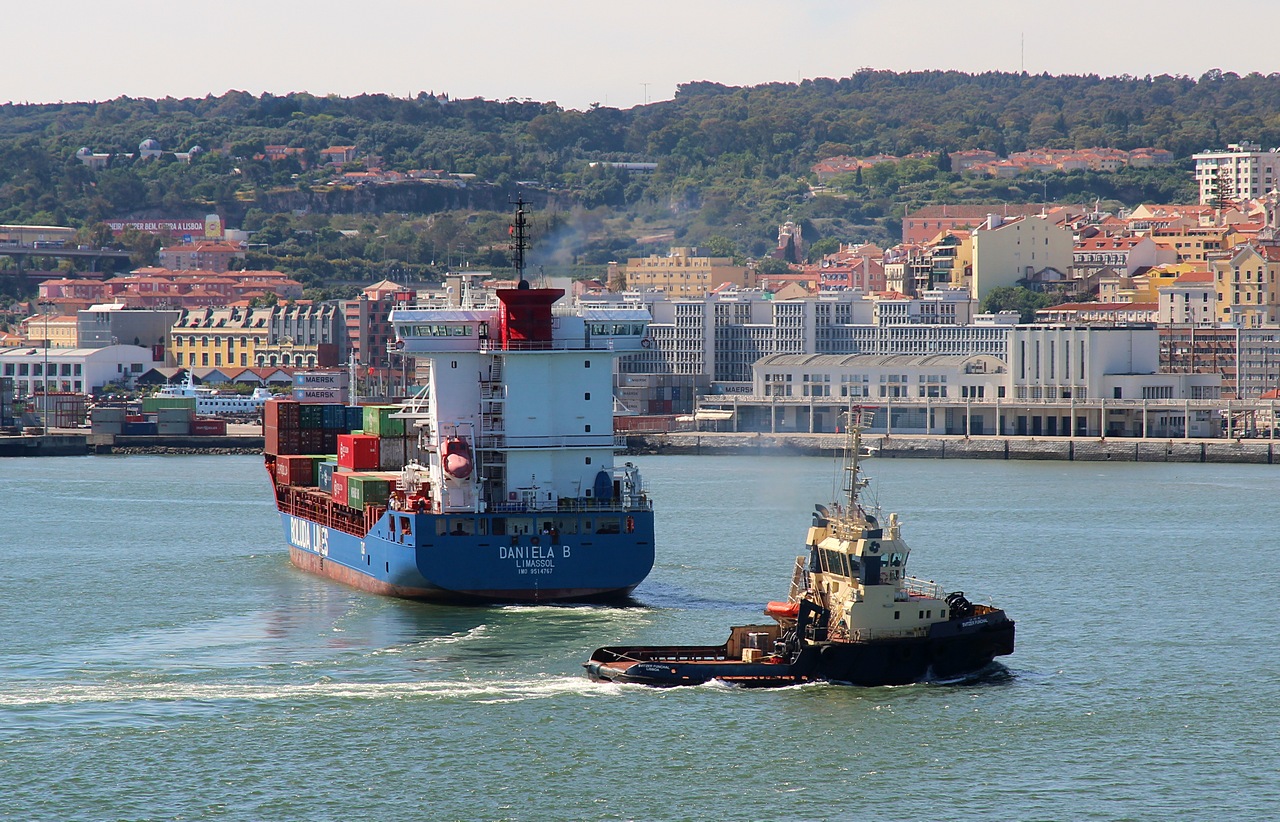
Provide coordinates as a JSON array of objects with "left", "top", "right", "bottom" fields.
[{"left": 626, "top": 433, "right": 1280, "bottom": 465}]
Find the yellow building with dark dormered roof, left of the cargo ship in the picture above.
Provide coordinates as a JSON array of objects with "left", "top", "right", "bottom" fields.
[{"left": 169, "top": 307, "right": 271, "bottom": 367}]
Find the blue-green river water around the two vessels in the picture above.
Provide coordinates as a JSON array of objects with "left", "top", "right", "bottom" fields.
[{"left": 0, "top": 456, "right": 1280, "bottom": 821}]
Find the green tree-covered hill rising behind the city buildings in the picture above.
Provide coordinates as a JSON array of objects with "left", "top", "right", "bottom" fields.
[{"left": 0, "top": 70, "right": 1264, "bottom": 291}]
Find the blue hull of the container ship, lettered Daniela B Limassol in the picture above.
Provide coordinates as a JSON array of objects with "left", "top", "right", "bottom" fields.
[{"left": 280, "top": 511, "right": 654, "bottom": 603}]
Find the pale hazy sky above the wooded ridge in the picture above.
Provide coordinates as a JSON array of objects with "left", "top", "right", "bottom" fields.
[{"left": 10, "top": 0, "right": 1280, "bottom": 109}]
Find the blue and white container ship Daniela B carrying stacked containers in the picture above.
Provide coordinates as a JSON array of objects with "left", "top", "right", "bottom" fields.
[{"left": 264, "top": 204, "right": 654, "bottom": 603}]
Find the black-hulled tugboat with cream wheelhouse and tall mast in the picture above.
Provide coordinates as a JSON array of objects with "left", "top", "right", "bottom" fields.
[{"left": 584, "top": 408, "right": 1014, "bottom": 688}]
